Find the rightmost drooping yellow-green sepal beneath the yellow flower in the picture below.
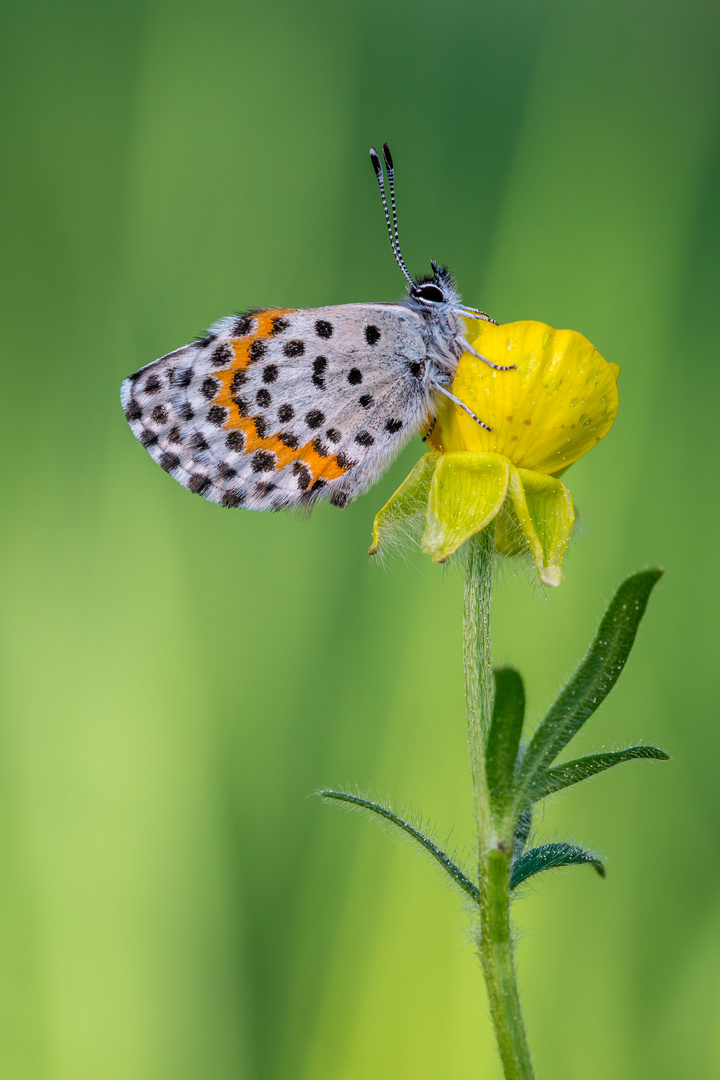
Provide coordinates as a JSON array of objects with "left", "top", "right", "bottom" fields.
[{"left": 507, "top": 468, "right": 575, "bottom": 585}]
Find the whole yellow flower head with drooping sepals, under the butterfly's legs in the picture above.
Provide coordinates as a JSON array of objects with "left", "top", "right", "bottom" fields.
[{"left": 370, "top": 322, "right": 620, "bottom": 585}]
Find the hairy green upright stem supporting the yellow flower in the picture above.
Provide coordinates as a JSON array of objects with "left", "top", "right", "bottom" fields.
[{"left": 463, "top": 526, "right": 534, "bottom": 1080}]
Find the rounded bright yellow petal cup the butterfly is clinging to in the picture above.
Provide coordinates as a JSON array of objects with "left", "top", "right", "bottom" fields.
[{"left": 430, "top": 322, "right": 620, "bottom": 473}]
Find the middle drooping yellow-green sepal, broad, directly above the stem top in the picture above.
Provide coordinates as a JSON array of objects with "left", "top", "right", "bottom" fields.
[{"left": 420, "top": 453, "right": 510, "bottom": 563}]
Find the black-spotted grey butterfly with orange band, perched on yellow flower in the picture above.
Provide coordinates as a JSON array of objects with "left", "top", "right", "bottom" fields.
[{"left": 121, "top": 143, "right": 507, "bottom": 510}]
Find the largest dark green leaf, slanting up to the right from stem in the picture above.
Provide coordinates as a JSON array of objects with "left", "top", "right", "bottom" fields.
[{"left": 517, "top": 569, "right": 663, "bottom": 805}]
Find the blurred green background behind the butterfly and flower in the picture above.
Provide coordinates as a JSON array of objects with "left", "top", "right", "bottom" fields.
[{"left": 0, "top": 0, "right": 720, "bottom": 1080}]
